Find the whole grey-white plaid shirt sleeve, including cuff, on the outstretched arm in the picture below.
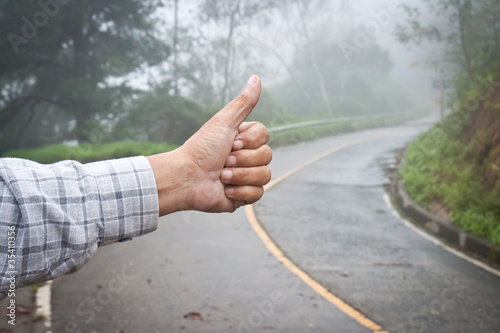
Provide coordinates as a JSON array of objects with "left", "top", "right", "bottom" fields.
[{"left": 0, "top": 156, "right": 159, "bottom": 299}]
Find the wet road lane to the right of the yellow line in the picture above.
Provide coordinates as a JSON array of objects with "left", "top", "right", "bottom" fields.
[{"left": 255, "top": 120, "right": 500, "bottom": 332}]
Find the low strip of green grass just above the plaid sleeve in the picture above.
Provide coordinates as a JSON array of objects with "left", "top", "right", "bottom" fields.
[{"left": 2, "top": 141, "right": 177, "bottom": 163}]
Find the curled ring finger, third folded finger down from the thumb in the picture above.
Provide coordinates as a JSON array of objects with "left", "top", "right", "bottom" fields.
[{"left": 220, "top": 166, "right": 271, "bottom": 186}]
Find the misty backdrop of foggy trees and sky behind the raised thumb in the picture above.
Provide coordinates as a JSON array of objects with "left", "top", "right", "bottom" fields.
[{"left": 0, "top": 0, "right": 446, "bottom": 156}]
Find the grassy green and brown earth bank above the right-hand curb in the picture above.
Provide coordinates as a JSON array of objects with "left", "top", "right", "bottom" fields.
[{"left": 400, "top": 81, "right": 500, "bottom": 244}]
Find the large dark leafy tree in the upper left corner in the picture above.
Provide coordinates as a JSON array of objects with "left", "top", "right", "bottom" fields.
[{"left": 0, "top": 0, "right": 169, "bottom": 150}]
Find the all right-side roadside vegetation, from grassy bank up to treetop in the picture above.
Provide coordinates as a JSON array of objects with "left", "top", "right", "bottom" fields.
[{"left": 399, "top": 0, "right": 500, "bottom": 245}]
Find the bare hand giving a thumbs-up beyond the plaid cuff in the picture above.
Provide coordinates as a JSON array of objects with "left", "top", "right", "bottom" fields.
[{"left": 148, "top": 76, "right": 272, "bottom": 216}]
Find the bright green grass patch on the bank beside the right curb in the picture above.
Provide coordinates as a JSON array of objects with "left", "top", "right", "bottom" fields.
[{"left": 400, "top": 124, "right": 500, "bottom": 245}]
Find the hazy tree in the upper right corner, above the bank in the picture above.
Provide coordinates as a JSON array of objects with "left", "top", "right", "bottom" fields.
[{"left": 396, "top": 0, "right": 500, "bottom": 96}]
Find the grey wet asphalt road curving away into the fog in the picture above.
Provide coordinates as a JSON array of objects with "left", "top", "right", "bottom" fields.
[{"left": 52, "top": 115, "right": 500, "bottom": 333}]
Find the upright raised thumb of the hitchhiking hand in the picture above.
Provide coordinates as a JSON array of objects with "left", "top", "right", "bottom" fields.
[{"left": 216, "top": 75, "right": 261, "bottom": 128}]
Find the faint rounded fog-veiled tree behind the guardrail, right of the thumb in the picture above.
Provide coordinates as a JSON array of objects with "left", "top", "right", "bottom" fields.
[{"left": 275, "top": 37, "right": 400, "bottom": 118}]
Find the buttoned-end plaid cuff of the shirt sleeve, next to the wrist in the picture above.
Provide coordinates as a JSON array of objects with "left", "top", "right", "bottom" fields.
[{"left": 87, "top": 156, "right": 159, "bottom": 246}]
